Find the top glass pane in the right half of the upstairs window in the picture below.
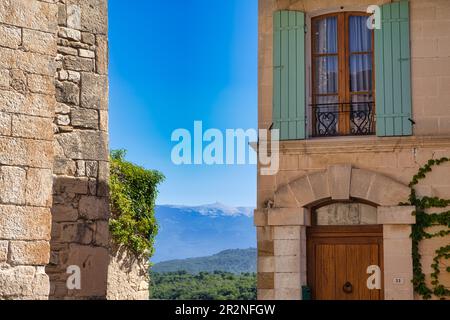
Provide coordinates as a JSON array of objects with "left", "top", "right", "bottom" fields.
[{"left": 349, "top": 16, "right": 372, "bottom": 52}]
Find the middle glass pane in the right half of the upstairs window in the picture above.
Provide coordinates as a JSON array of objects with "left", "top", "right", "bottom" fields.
[{"left": 350, "top": 54, "right": 373, "bottom": 92}]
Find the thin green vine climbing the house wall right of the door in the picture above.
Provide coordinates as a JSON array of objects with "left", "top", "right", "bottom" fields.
[{"left": 407, "top": 158, "right": 450, "bottom": 299}]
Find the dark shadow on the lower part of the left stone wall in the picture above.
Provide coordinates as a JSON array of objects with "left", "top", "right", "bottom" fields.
[{"left": 46, "top": 175, "right": 109, "bottom": 299}]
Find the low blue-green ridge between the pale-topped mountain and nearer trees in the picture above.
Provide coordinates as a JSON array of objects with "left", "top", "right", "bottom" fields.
[{"left": 152, "top": 248, "right": 256, "bottom": 274}]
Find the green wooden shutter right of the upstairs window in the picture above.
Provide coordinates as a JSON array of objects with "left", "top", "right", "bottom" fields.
[{"left": 375, "top": 1, "right": 412, "bottom": 137}]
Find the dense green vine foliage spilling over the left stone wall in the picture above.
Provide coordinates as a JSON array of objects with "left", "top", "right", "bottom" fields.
[{"left": 109, "top": 150, "right": 164, "bottom": 258}]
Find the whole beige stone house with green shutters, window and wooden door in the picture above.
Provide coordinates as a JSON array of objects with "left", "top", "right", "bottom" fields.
[{"left": 255, "top": 0, "right": 450, "bottom": 300}]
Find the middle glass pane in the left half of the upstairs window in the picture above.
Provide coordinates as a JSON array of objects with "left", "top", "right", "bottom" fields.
[{"left": 314, "top": 56, "right": 338, "bottom": 94}]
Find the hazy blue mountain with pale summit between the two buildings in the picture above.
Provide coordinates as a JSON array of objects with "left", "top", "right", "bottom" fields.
[{"left": 151, "top": 203, "right": 256, "bottom": 263}]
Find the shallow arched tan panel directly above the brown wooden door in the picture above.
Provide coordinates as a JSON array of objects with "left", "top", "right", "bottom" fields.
[{"left": 316, "top": 203, "right": 377, "bottom": 226}]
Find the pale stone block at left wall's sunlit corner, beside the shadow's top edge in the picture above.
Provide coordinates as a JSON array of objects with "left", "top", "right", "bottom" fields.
[{"left": 26, "top": 168, "right": 53, "bottom": 207}]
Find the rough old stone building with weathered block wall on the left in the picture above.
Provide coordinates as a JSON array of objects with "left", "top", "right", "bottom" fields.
[{"left": 0, "top": 0, "right": 148, "bottom": 299}]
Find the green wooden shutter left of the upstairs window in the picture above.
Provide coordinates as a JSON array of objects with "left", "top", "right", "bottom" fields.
[{"left": 273, "top": 11, "right": 306, "bottom": 140}]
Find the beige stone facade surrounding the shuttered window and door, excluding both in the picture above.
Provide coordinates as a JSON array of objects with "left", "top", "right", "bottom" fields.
[{"left": 255, "top": 0, "right": 450, "bottom": 299}]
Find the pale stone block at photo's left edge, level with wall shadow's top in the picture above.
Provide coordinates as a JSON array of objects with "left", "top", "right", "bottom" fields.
[{"left": 0, "top": 166, "right": 26, "bottom": 204}]
